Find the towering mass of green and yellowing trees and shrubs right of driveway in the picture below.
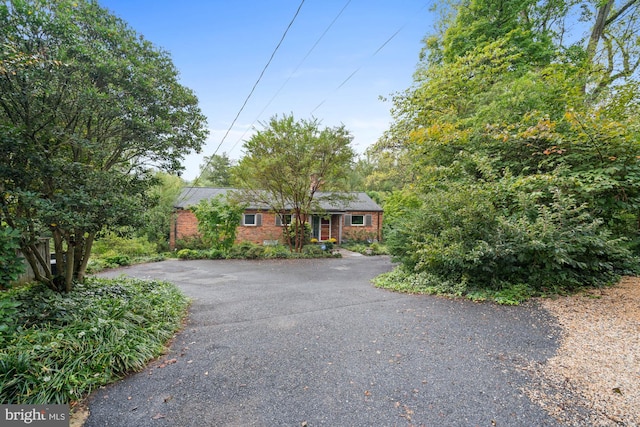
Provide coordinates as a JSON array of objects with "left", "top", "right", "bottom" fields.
[{"left": 376, "top": 0, "right": 640, "bottom": 303}]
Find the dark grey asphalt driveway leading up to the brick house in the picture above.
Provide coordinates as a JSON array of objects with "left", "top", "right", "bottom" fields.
[{"left": 85, "top": 252, "right": 558, "bottom": 427}]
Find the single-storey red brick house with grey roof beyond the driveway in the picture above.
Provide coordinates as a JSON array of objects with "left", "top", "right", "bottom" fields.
[{"left": 169, "top": 187, "right": 383, "bottom": 249}]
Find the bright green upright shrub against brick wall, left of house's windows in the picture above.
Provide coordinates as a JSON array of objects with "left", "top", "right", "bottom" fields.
[{"left": 191, "top": 196, "right": 244, "bottom": 252}]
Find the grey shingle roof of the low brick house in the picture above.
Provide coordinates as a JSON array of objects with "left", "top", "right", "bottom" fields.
[{"left": 175, "top": 187, "right": 382, "bottom": 212}]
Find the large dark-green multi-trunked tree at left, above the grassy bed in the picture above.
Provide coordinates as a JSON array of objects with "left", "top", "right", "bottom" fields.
[{"left": 0, "top": 0, "right": 206, "bottom": 290}]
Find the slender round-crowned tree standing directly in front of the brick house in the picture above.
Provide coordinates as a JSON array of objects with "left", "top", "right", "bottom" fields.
[{"left": 234, "top": 115, "right": 354, "bottom": 251}]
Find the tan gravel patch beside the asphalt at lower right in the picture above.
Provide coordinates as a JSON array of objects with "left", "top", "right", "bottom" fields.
[{"left": 524, "top": 277, "right": 640, "bottom": 426}]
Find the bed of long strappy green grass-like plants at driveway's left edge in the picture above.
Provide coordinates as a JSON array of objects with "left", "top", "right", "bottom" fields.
[{"left": 0, "top": 278, "right": 188, "bottom": 404}]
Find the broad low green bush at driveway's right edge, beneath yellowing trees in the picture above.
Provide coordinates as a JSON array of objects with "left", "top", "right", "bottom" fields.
[{"left": 386, "top": 186, "right": 637, "bottom": 301}]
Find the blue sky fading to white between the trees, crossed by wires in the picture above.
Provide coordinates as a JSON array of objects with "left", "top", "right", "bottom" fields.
[{"left": 99, "top": 0, "right": 434, "bottom": 180}]
